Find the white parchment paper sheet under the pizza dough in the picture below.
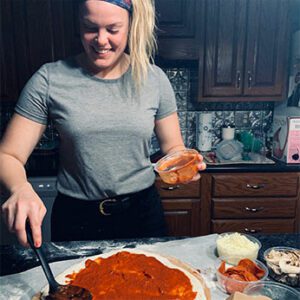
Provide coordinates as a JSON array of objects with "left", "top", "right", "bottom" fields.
[{"left": 0, "top": 234, "right": 228, "bottom": 300}]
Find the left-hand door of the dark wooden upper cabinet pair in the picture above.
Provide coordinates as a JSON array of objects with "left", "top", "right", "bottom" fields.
[{"left": 199, "top": 0, "right": 246, "bottom": 97}]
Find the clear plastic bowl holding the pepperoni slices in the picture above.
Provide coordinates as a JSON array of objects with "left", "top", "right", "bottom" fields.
[{"left": 215, "top": 258, "right": 269, "bottom": 294}]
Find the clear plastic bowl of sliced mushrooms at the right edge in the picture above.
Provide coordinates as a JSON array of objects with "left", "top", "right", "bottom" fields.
[{"left": 263, "top": 247, "right": 300, "bottom": 287}]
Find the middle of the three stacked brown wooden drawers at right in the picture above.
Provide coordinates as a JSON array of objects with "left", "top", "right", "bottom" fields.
[{"left": 212, "top": 198, "right": 297, "bottom": 219}]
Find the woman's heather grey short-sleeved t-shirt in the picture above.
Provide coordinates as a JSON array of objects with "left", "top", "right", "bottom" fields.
[{"left": 15, "top": 58, "right": 177, "bottom": 200}]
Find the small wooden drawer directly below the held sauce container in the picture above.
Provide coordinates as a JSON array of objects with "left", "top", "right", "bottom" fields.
[{"left": 155, "top": 178, "right": 200, "bottom": 198}]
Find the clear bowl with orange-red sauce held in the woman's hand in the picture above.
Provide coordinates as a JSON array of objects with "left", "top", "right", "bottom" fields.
[{"left": 154, "top": 149, "right": 200, "bottom": 184}]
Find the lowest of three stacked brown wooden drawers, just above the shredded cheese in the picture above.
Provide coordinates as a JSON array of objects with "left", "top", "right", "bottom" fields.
[{"left": 212, "top": 219, "right": 295, "bottom": 233}]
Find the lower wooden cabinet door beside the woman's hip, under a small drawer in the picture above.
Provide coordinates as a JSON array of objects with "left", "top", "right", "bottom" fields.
[{"left": 162, "top": 199, "right": 200, "bottom": 236}]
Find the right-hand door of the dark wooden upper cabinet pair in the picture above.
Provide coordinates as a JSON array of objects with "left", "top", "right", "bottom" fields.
[{"left": 244, "top": 0, "right": 288, "bottom": 100}]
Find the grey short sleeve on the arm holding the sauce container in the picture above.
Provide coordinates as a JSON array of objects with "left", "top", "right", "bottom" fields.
[{"left": 155, "top": 68, "right": 177, "bottom": 120}]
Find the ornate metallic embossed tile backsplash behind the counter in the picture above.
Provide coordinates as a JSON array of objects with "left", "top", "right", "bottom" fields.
[{"left": 151, "top": 67, "right": 274, "bottom": 153}]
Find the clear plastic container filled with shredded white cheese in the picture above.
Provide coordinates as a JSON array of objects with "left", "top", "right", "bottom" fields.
[{"left": 216, "top": 232, "right": 261, "bottom": 264}]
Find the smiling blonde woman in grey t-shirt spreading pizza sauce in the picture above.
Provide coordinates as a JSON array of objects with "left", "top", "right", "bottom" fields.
[{"left": 0, "top": 0, "right": 205, "bottom": 247}]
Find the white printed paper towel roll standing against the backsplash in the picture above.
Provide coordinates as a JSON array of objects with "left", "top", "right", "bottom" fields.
[{"left": 196, "top": 111, "right": 212, "bottom": 151}]
